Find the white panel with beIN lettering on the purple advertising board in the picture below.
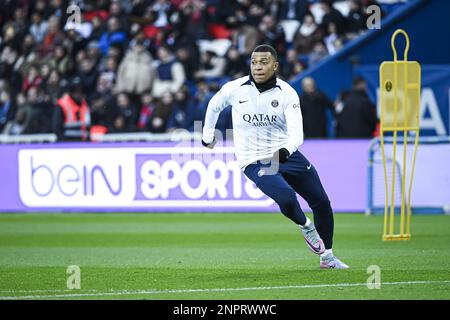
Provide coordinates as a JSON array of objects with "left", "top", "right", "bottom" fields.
[{"left": 19, "top": 148, "right": 135, "bottom": 207}]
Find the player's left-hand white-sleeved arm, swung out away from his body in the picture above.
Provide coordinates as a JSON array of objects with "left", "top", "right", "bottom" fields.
[{"left": 202, "top": 87, "right": 228, "bottom": 149}]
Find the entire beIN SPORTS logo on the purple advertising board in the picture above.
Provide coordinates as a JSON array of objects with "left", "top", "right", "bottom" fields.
[{"left": 19, "top": 147, "right": 273, "bottom": 208}]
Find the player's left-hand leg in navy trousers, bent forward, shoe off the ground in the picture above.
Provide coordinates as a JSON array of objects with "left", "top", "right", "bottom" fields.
[{"left": 245, "top": 163, "right": 325, "bottom": 254}]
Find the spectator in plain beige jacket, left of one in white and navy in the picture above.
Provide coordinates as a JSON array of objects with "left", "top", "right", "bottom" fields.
[{"left": 116, "top": 41, "right": 155, "bottom": 98}]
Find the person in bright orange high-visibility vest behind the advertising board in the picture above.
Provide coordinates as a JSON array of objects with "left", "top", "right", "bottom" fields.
[{"left": 52, "top": 78, "right": 91, "bottom": 141}]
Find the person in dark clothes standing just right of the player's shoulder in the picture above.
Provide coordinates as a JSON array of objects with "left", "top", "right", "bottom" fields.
[{"left": 300, "top": 77, "right": 334, "bottom": 138}]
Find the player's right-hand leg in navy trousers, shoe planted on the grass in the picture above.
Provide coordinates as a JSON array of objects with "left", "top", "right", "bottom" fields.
[{"left": 280, "top": 151, "right": 348, "bottom": 268}]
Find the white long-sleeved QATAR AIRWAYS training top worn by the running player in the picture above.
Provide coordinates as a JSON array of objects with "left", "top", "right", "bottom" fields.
[{"left": 202, "top": 76, "right": 303, "bottom": 170}]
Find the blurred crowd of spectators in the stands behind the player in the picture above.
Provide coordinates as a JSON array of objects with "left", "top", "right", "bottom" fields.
[{"left": 0, "top": 0, "right": 386, "bottom": 140}]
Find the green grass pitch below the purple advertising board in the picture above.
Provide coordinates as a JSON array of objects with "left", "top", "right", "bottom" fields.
[{"left": 0, "top": 213, "right": 450, "bottom": 300}]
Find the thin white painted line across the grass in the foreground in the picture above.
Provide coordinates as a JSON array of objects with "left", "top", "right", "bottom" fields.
[{"left": 0, "top": 280, "right": 450, "bottom": 300}]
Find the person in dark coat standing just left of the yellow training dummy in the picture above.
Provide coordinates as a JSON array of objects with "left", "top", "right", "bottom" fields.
[{"left": 336, "top": 77, "right": 378, "bottom": 138}]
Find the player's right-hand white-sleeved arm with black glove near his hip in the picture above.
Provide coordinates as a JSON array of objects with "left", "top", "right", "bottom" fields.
[{"left": 276, "top": 92, "right": 303, "bottom": 163}]
